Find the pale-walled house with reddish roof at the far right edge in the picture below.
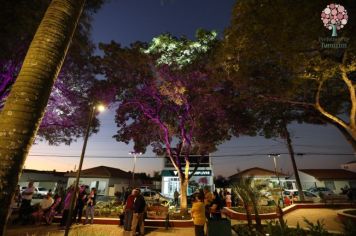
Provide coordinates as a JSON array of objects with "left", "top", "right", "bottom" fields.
[{"left": 290, "top": 169, "right": 356, "bottom": 193}]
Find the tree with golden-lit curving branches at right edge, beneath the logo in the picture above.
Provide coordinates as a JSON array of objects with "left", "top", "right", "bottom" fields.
[{"left": 220, "top": 0, "right": 356, "bottom": 147}]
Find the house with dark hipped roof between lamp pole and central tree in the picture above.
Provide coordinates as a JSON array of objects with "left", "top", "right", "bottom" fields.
[{"left": 66, "top": 166, "right": 133, "bottom": 196}]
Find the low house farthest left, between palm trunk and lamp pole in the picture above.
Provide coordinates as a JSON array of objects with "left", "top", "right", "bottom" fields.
[{"left": 18, "top": 169, "right": 68, "bottom": 191}]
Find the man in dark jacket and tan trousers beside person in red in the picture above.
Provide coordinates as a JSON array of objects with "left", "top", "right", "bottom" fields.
[{"left": 131, "top": 188, "right": 146, "bottom": 236}]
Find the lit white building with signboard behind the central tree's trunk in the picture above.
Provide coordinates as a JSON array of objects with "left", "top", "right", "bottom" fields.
[{"left": 162, "top": 155, "right": 214, "bottom": 197}]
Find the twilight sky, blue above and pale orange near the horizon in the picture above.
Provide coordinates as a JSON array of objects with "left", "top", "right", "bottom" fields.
[{"left": 25, "top": 0, "right": 355, "bottom": 176}]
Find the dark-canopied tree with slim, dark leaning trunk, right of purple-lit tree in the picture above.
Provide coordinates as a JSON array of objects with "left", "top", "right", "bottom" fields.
[{"left": 214, "top": 0, "right": 353, "bottom": 201}]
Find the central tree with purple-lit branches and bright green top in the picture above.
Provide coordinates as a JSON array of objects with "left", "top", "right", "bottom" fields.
[{"left": 94, "top": 31, "right": 247, "bottom": 212}]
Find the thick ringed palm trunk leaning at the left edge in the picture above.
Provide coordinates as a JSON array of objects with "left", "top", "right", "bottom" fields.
[{"left": 0, "top": 0, "right": 85, "bottom": 235}]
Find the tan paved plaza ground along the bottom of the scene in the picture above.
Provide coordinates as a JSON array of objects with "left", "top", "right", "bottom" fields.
[{"left": 6, "top": 209, "right": 343, "bottom": 236}]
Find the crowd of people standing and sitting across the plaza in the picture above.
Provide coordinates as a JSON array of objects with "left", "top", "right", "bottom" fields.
[{"left": 10, "top": 182, "right": 232, "bottom": 236}]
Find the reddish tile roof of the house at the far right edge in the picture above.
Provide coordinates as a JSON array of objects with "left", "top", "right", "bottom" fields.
[{"left": 299, "top": 169, "right": 356, "bottom": 180}]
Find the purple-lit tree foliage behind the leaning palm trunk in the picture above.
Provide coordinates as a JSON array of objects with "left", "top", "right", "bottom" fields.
[{"left": 0, "top": 1, "right": 101, "bottom": 144}]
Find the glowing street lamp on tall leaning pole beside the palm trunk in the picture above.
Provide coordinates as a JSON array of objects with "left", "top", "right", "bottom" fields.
[{"left": 64, "top": 104, "right": 105, "bottom": 236}]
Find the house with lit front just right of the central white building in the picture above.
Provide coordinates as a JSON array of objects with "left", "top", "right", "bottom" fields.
[{"left": 229, "top": 167, "right": 288, "bottom": 187}]
